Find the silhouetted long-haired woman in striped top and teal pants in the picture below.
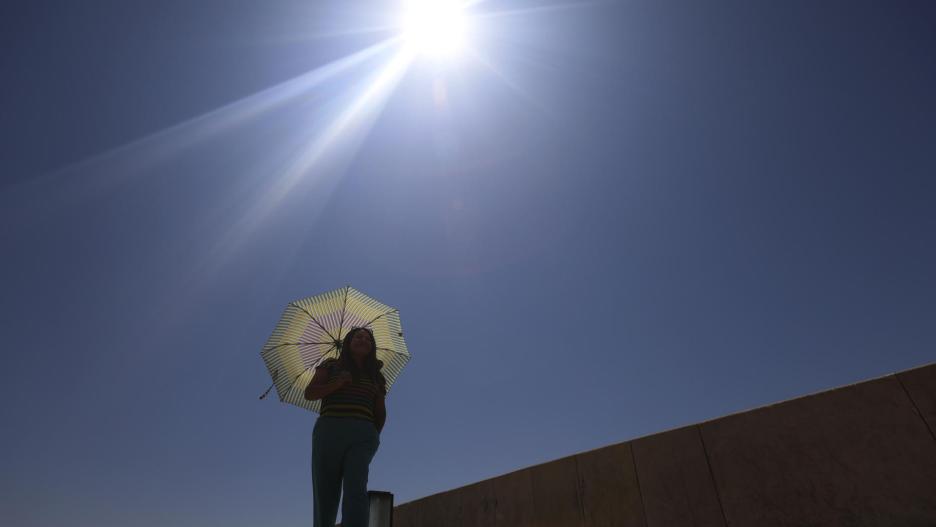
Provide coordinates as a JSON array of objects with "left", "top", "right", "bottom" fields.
[{"left": 305, "top": 327, "right": 387, "bottom": 527}]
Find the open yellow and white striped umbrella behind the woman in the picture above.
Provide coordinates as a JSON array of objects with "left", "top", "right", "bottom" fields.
[{"left": 260, "top": 286, "right": 410, "bottom": 412}]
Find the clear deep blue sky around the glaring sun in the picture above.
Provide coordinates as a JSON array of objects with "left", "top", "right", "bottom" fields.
[{"left": 0, "top": 0, "right": 936, "bottom": 527}]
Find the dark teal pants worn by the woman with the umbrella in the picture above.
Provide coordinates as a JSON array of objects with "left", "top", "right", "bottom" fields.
[{"left": 312, "top": 416, "right": 380, "bottom": 527}]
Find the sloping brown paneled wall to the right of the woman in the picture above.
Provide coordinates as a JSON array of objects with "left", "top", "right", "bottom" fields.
[{"left": 393, "top": 364, "right": 936, "bottom": 527}]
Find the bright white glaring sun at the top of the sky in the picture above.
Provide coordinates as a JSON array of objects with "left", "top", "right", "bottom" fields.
[{"left": 402, "top": 0, "right": 468, "bottom": 58}]
